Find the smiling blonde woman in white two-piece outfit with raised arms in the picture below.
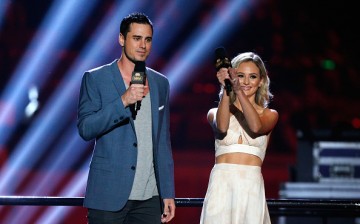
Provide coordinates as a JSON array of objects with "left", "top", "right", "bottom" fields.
[{"left": 200, "top": 52, "right": 278, "bottom": 224}]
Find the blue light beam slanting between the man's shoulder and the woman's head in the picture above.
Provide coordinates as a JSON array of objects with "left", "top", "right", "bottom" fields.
[{"left": 163, "top": 0, "right": 249, "bottom": 97}]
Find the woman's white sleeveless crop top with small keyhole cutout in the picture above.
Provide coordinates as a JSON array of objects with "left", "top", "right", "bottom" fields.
[{"left": 214, "top": 115, "right": 268, "bottom": 161}]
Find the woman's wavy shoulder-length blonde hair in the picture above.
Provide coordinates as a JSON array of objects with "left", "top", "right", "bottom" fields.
[{"left": 219, "top": 52, "right": 273, "bottom": 108}]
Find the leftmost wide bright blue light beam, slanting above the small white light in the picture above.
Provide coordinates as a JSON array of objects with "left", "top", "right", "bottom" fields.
[{"left": 0, "top": 0, "right": 96, "bottom": 148}]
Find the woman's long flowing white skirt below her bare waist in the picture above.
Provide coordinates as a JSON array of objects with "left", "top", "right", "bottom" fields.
[{"left": 200, "top": 163, "right": 271, "bottom": 224}]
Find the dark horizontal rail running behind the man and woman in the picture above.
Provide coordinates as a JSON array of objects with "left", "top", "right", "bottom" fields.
[{"left": 0, "top": 196, "right": 360, "bottom": 217}]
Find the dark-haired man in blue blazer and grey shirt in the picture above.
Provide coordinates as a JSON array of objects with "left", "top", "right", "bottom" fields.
[{"left": 77, "top": 13, "right": 175, "bottom": 224}]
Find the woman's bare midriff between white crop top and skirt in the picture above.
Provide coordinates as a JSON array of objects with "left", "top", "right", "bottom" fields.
[{"left": 215, "top": 152, "right": 262, "bottom": 166}]
